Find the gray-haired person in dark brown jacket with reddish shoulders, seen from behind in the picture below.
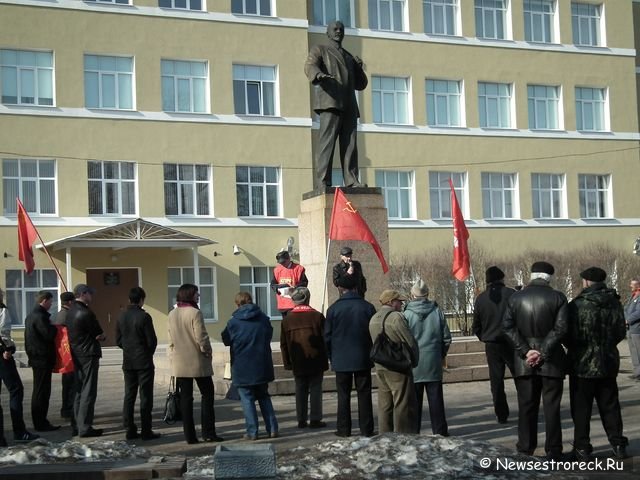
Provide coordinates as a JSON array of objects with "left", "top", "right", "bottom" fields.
[{"left": 280, "top": 287, "right": 329, "bottom": 428}]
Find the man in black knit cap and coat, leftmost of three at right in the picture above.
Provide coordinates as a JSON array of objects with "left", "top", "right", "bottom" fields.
[{"left": 471, "top": 266, "right": 515, "bottom": 423}]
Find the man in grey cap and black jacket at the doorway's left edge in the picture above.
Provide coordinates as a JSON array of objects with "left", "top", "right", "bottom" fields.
[{"left": 67, "top": 283, "right": 105, "bottom": 437}]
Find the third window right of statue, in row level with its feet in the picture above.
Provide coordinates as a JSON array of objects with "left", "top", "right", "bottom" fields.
[{"left": 482, "top": 173, "right": 518, "bottom": 219}]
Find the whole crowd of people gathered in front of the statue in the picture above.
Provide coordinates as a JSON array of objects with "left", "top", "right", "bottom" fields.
[{"left": 0, "top": 247, "right": 640, "bottom": 460}]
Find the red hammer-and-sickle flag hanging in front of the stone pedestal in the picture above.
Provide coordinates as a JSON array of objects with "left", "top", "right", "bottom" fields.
[{"left": 329, "top": 188, "right": 389, "bottom": 273}]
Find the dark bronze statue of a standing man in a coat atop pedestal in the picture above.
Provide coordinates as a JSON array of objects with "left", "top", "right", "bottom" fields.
[{"left": 304, "top": 21, "right": 369, "bottom": 188}]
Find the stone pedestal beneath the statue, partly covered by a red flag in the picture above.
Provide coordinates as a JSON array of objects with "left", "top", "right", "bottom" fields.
[{"left": 298, "top": 188, "right": 389, "bottom": 313}]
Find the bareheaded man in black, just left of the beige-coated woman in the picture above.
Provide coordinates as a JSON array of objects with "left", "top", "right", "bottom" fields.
[{"left": 116, "top": 287, "right": 160, "bottom": 440}]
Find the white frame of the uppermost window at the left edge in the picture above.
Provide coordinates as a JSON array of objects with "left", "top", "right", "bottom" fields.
[{"left": 0, "top": 48, "right": 56, "bottom": 107}]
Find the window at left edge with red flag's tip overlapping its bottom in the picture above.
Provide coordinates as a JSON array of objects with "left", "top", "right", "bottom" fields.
[{"left": 2, "top": 159, "right": 56, "bottom": 215}]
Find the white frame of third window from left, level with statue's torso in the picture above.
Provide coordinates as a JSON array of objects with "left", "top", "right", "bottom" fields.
[{"left": 160, "top": 58, "right": 211, "bottom": 114}]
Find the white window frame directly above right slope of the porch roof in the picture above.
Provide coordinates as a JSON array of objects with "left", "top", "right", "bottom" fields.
[{"left": 163, "top": 163, "right": 213, "bottom": 217}]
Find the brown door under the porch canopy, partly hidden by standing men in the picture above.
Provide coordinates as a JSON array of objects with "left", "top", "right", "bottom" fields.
[{"left": 87, "top": 268, "right": 138, "bottom": 347}]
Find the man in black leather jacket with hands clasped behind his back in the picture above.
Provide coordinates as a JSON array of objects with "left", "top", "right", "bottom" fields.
[{"left": 502, "top": 262, "right": 568, "bottom": 460}]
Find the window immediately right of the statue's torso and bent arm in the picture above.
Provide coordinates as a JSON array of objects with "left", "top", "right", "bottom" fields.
[{"left": 372, "top": 76, "right": 409, "bottom": 125}]
